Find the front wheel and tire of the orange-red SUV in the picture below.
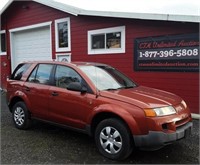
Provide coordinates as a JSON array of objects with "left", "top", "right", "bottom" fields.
[{"left": 95, "top": 118, "right": 133, "bottom": 160}]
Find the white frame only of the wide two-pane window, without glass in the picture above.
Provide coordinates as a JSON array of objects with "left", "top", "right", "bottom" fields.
[{"left": 88, "top": 26, "right": 126, "bottom": 55}]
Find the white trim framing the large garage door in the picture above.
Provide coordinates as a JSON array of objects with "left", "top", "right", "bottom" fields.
[{"left": 9, "top": 21, "right": 52, "bottom": 72}]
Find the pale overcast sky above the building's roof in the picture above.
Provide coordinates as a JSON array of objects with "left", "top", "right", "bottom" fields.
[{"left": 0, "top": 0, "right": 200, "bottom": 16}]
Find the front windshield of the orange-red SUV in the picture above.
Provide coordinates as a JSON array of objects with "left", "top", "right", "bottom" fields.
[{"left": 79, "top": 66, "right": 136, "bottom": 90}]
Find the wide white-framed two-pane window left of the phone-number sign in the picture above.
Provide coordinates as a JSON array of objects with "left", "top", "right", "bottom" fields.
[{"left": 88, "top": 26, "right": 125, "bottom": 54}]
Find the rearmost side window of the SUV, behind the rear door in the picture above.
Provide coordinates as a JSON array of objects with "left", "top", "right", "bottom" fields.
[{"left": 11, "top": 64, "right": 31, "bottom": 80}]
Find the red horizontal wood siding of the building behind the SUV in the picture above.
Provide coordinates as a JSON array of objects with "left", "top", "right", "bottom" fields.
[{"left": 1, "top": 1, "right": 199, "bottom": 113}]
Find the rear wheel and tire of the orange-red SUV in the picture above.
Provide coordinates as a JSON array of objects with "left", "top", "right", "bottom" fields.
[{"left": 12, "top": 101, "right": 31, "bottom": 130}]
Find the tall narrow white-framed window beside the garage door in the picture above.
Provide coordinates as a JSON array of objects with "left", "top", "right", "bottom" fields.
[{"left": 55, "top": 18, "right": 71, "bottom": 52}]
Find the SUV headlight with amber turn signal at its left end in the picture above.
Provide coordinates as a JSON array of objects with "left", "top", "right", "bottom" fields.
[{"left": 144, "top": 106, "right": 176, "bottom": 117}]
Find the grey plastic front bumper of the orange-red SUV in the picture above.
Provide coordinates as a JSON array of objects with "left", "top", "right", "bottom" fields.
[{"left": 133, "top": 122, "right": 193, "bottom": 150}]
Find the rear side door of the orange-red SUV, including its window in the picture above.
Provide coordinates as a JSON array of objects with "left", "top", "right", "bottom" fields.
[{"left": 23, "top": 64, "right": 53, "bottom": 119}]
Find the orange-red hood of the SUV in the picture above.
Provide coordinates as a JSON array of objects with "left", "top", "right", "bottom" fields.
[{"left": 100, "top": 86, "right": 182, "bottom": 108}]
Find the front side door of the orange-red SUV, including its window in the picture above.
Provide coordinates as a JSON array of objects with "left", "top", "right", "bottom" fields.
[{"left": 49, "top": 65, "right": 95, "bottom": 129}]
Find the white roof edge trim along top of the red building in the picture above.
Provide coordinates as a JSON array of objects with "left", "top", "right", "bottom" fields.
[{"left": 0, "top": 0, "right": 200, "bottom": 23}]
